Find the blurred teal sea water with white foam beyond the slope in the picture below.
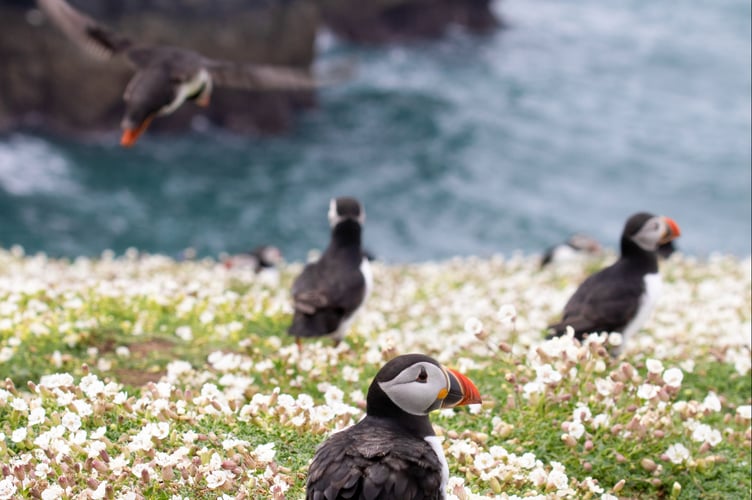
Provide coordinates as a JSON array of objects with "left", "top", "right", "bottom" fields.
[{"left": 0, "top": 0, "right": 752, "bottom": 262}]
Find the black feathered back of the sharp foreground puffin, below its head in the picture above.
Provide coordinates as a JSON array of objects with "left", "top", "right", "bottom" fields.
[{"left": 306, "top": 417, "right": 441, "bottom": 500}]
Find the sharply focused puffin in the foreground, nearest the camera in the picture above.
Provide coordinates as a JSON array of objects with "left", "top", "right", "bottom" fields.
[{"left": 306, "top": 354, "right": 481, "bottom": 500}]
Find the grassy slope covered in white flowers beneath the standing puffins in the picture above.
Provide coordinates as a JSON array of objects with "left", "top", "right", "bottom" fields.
[{"left": 0, "top": 253, "right": 752, "bottom": 498}]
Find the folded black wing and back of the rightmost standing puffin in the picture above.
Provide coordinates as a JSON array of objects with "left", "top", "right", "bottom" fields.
[{"left": 549, "top": 262, "right": 645, "bottom": 339}]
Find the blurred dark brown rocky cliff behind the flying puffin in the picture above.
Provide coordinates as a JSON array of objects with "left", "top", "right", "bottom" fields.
[{"left": 0, "top": 0, "right": 496, "bottom": 137}]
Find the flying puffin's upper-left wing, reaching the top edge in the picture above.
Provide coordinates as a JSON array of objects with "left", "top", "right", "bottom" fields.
[{"left": 37, "top": 0, "right": 133, "bottom": 60}]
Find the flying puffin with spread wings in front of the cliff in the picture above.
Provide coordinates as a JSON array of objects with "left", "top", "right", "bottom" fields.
[{"left": 37, "top": 0, "right": 342, "bottom": 146}]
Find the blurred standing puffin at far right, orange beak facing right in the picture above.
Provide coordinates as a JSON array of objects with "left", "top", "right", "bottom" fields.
[{"left": 549, "top": 212, "right": 680, "bottom": 354}]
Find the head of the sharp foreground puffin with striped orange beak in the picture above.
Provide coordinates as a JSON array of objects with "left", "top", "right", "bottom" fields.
[{"left": 366, "top": 354, "right": 481, "bottom": 416}]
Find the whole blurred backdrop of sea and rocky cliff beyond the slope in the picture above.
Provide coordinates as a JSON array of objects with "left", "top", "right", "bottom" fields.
[{"left": 0, "top": 0, "right": 752, "bottom": 262}]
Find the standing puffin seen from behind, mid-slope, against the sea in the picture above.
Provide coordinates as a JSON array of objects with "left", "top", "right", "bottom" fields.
[{"left": 288, "top": 196, "right": 373, "bottom": 348}]
